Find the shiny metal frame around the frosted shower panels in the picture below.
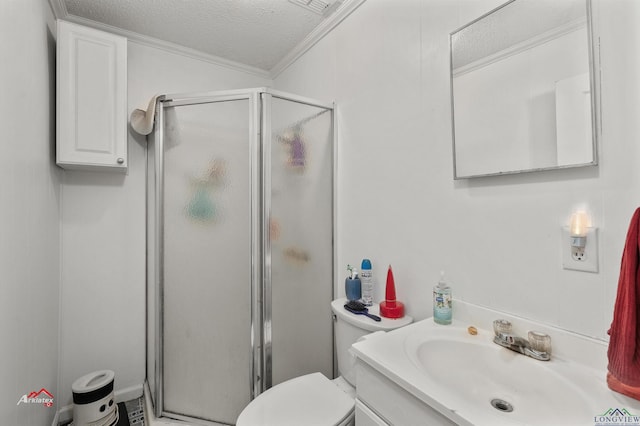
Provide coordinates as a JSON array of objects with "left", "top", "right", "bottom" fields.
[{"left": 147, "top": 87, "right": 337, "bottom": 420}]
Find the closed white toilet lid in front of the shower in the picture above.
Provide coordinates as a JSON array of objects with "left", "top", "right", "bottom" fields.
[{"left": 236, "top": 373, "right": 355, "bottom": 426}]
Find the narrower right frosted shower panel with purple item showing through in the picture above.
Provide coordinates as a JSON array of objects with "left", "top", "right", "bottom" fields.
[{"left": 270, "top": 97, "right": 333, "bottom": 385}]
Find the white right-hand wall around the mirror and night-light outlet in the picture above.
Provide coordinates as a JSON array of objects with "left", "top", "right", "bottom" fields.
[{"left": 275, "top": 0, "right": 640, "bottom": 339}]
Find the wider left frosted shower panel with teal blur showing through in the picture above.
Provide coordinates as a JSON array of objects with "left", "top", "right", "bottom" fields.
[{"left": 164, "top": 100, "right": 252, "bottom": 423}]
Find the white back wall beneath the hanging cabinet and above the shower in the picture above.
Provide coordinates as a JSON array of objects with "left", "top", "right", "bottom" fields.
[{"left": 60, "top": 42, "right": 271, "bottom": 405}]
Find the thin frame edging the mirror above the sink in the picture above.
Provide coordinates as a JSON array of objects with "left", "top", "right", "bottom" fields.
[{"left": 449, "top": 0, "right": 601, "bottom": 180}]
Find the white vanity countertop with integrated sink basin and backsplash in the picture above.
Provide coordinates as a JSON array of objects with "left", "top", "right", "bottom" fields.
[{"left": 352, "top": 301, "right": 640, "bottom": 426}]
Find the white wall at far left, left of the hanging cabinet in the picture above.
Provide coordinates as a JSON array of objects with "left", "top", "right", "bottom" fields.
[{"left": 0, "top": 0, "right": 60, "bottom": 425}]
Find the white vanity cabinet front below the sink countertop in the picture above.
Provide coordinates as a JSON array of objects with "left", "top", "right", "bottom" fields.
[{"left": 355, "top": 359, "right": 456, "bottom": 426}]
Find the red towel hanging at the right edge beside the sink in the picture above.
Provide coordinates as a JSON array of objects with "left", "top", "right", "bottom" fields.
[{"left": 607, "top": 208, "right": 640, "bottom": 399}]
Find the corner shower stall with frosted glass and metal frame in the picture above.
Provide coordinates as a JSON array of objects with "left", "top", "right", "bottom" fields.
[{"left": 147, "top": 88, "right": 336, "bottom": 424}]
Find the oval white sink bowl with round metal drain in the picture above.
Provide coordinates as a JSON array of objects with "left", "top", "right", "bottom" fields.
[{"left": 404, "top": 327, "right": 592, "bottom": 424}]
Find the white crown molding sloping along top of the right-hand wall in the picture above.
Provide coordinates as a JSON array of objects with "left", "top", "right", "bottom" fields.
[{"left": 270, "top": 0, "right": 367, "bottom": 79}]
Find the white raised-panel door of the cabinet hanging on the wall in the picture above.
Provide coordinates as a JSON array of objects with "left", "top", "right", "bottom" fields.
[{"left": 56, "top": 21, "right": 127, "bottom": 171}]
